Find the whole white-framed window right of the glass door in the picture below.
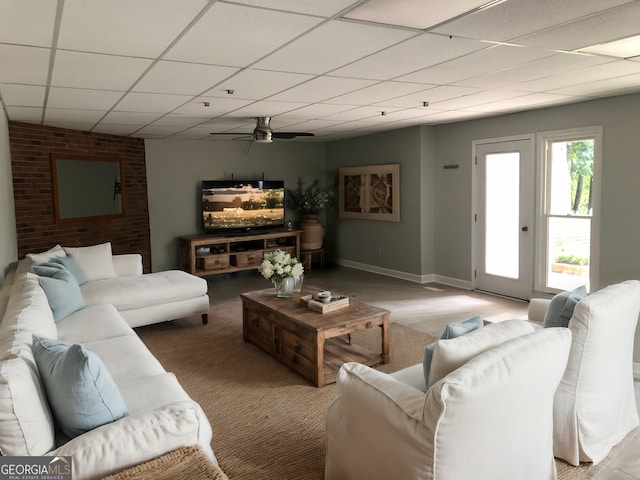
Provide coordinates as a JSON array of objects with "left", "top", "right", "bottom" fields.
[{"left": 537, "top": 128, "right": 601, "bottom": 291}]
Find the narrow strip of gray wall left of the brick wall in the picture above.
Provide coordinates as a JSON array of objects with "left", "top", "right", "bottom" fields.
[{"left": 0, "top": 101, "right": 18, "bottom": 284}]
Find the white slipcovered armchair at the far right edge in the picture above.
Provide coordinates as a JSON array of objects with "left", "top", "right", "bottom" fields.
[{"left": 529, "top": 280, "right": 640, "bottom": 465}]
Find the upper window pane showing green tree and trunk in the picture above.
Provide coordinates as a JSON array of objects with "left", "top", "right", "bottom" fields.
[{"left": 549, "top": 139, "right": 594, "bottom": 215}]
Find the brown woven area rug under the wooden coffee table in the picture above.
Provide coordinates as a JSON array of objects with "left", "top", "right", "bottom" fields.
[{"left": 137, "top": 301, "right": 628, "bottom": 480}]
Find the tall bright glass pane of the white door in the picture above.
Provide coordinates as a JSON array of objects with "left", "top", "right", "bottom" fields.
[{"left": 485, "top": 152, "right": 520, "bottom": 278}]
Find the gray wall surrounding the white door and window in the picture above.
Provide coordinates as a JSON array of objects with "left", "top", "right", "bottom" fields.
[{"left": 433, "top": 94, "right": 640, "bottom": 362}]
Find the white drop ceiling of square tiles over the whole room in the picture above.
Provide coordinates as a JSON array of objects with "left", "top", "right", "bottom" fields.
[{"left": 0, "top": 0, "right": 640, "bottom": 141}]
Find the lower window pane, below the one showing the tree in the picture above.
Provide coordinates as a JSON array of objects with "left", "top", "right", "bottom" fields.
[{"left": 547, "top": 217, "right": 591, "bottom": 290}]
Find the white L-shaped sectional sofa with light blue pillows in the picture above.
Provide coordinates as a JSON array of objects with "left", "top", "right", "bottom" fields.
[{"left": 0, "top": 249, "right": 215, "bottom": 480}]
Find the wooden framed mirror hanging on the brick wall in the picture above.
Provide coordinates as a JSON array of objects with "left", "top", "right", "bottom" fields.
[{"left": 51, "top": 154, "right": 125, "bottom": 223}]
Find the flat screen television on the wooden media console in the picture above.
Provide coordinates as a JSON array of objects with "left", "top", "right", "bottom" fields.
[{"left": 202, "top": 180, "right": 285, "bottom": 234}]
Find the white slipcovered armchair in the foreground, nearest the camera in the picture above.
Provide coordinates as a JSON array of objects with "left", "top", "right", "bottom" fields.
[{"left": 325, "top": 321, "right": 571, "bottom": 480}]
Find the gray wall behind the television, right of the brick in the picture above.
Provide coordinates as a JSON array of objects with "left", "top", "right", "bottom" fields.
[{"left": 145, "top": 140, "right": 324, "bottom": 272}]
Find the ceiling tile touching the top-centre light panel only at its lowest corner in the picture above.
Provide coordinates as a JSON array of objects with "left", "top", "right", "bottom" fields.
[{"left": 332, "top": 33, "right": 488, "bottom": 80}]
